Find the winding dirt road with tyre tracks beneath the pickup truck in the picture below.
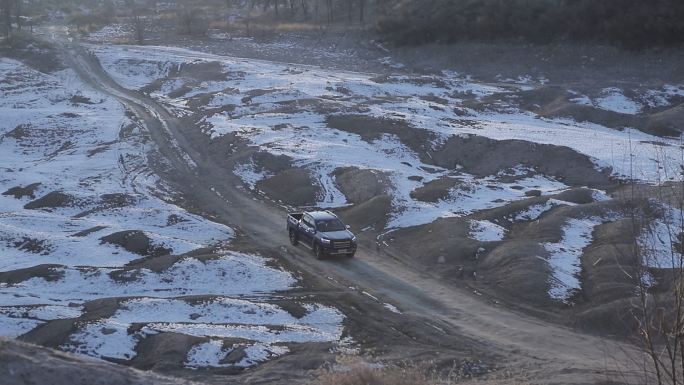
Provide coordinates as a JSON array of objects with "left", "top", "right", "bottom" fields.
[{"left": 54, "top": 37, "right": 642, "bottom": 383}]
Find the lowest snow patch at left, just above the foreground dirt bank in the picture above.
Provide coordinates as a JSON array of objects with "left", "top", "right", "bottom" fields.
[{"left": 63, "top": 298, "right": 344, "bottom": 367}]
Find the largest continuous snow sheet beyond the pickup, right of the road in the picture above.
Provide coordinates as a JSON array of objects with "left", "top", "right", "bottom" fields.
[{"left": 91, "top": 46, "right": 668, "bottom": 227}]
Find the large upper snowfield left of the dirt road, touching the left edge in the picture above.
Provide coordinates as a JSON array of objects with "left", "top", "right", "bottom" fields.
[{"left": 0, "top": 59, "right": 233, "bottom": 271}]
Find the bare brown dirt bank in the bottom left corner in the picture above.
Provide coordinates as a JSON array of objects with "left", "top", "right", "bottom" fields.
[{"left": 0, "top": 339, "right": 193, "bottom": 385}]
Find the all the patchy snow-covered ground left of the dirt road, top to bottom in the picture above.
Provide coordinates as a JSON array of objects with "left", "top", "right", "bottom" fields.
[{"left": 0, "top": 58, "right": 344, "bottom": 368}]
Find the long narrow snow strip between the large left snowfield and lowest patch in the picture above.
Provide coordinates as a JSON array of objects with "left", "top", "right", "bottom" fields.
[{"left": 0, "top": 252, "right": 296, "bottom": 305}]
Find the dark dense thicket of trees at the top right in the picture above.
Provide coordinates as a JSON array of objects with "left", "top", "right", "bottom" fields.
[{"left": 379, "top": 0, "right": 684, "bottom": 48}]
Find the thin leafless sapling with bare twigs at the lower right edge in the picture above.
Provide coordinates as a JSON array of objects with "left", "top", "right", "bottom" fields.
[{"left": 629, "top": 154, "right": 684, "bottom": 385}]
